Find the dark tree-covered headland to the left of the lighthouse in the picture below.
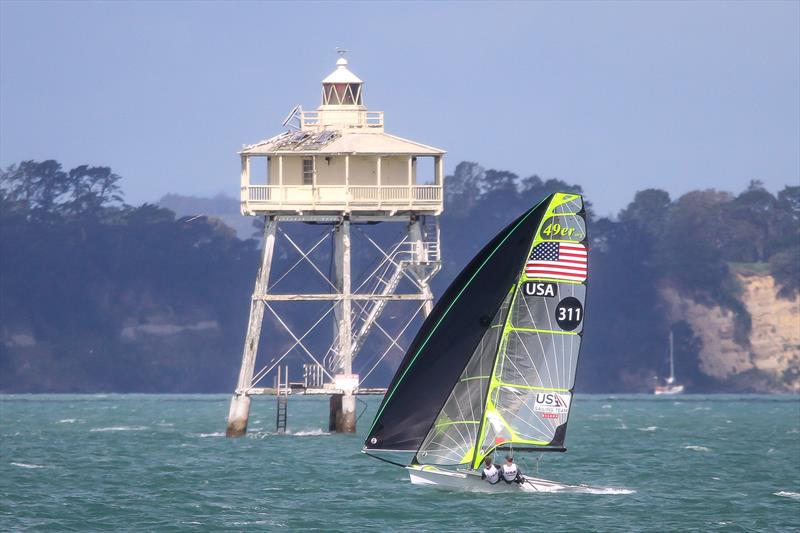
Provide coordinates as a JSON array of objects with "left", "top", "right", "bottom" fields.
[{"left": 0, "top": 161, "right": 258, "bottom": 392}]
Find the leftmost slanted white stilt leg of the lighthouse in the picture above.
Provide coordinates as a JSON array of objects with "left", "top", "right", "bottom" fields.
[{"left": 225, "top": 217, "right": 278, "bottom": 437}]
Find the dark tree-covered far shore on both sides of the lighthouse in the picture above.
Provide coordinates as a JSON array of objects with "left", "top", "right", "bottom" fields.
[{"left": 0, "top": 161, "right": 800, "bottom": 392}]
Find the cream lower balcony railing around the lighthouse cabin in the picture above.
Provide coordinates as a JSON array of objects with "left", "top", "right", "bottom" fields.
[{"left": 242, "top": 185, "right": 442, "bottom": 212}]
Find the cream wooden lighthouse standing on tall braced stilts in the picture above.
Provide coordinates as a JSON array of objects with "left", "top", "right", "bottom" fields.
[{"left": 226, "top": 57, "right": 445, "bottom": 436}]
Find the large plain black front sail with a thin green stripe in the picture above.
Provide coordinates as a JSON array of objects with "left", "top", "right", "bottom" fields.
[{"left": 364, "top": 196, "right": 552, "bottom": 451}]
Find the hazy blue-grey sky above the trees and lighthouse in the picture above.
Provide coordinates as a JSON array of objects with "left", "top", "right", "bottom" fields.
[{"left": 0, "top": 0, "right": 800, "bottom": 214}]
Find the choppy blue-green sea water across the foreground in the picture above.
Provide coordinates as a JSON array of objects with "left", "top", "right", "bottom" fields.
[{"left": 0, "top": 394, "right": 800, "bottom": 532}]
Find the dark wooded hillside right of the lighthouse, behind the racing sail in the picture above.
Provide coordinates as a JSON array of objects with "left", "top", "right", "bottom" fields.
[{"left": 438, "top": 163, "right": 800, "bottom": 391}]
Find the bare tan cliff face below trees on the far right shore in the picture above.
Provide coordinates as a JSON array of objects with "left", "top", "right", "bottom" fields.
[{"left": 661, "top": 274, "right": 800, "bottom": 392}]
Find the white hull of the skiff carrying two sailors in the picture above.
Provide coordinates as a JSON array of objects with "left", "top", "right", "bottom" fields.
[{"left": 406, "top": 465, "right": 581, "bottom": 492}]
